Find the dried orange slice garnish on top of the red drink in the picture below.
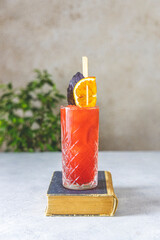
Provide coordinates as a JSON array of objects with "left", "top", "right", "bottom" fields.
[{"left": 73, "top": 77, "right": 97, "bottom": 107}]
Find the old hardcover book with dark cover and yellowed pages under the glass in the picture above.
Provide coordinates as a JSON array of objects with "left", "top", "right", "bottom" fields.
[{"left": 46, "top": 171, "right": 118, "bottom": 216}]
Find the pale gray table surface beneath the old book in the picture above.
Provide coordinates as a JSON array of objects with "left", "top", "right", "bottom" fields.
[{"left": 0, "top": 152, "right": 160, "bottom": 240}]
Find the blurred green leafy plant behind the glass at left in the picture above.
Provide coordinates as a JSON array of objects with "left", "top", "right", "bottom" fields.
[{"left": 0, "top": 70, "right": 65, "bottom": 152}]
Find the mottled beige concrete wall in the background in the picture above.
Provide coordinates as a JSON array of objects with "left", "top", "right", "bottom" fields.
[{"left": 0, "top": 0, "right": 160, "bottom": 150}]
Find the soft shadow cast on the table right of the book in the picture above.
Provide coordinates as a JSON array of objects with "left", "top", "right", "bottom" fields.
[{"left": 114, "top": 187, "right": 160, "bottom": 216}]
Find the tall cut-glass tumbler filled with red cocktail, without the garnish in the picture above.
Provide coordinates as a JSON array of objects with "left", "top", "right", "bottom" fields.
[{"left": 61, "top": 105, "right": 99, "bottom": 189}]
